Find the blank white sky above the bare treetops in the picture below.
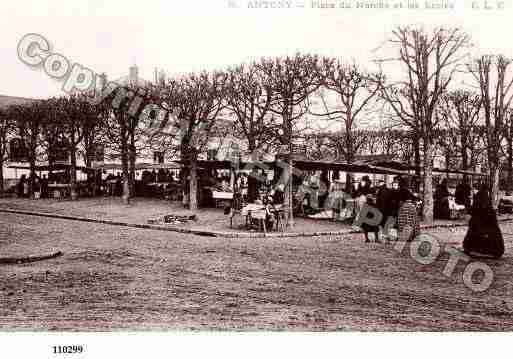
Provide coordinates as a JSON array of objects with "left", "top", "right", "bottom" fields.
[{"left": 0, "top": 0, "right": 513, "bottom": 98}]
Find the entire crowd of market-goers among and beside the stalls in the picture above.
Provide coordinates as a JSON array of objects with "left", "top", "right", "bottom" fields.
[{"left": 11, "top": 166, "right": 504, "bottom": 258}]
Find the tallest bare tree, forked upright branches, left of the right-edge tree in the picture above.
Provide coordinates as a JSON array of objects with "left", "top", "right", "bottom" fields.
[{"left": 380, "top": 27, "right": 469, "bottom": 223}]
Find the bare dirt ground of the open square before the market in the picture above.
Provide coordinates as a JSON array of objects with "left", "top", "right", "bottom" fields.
[{"left": 0, "top": 213, "right": 513, "bottom": 331}]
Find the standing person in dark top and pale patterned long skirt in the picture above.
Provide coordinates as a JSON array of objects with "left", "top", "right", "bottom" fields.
[{"left": 396, "top": 178, "right": 420, "bottom": 242}]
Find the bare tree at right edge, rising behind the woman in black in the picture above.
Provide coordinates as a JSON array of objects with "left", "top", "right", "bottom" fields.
[{"left": 468, "top": 55, "right": 513, "bottom": 207}]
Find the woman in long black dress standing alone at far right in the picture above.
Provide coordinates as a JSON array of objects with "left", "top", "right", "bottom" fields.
[{"left": 463, "top": 184, "right": 504, "bottom": 258}]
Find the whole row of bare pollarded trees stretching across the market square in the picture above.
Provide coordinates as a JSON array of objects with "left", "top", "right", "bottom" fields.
[{"left": 0, "top": 27, "right": 513, "bottom": 221}]
